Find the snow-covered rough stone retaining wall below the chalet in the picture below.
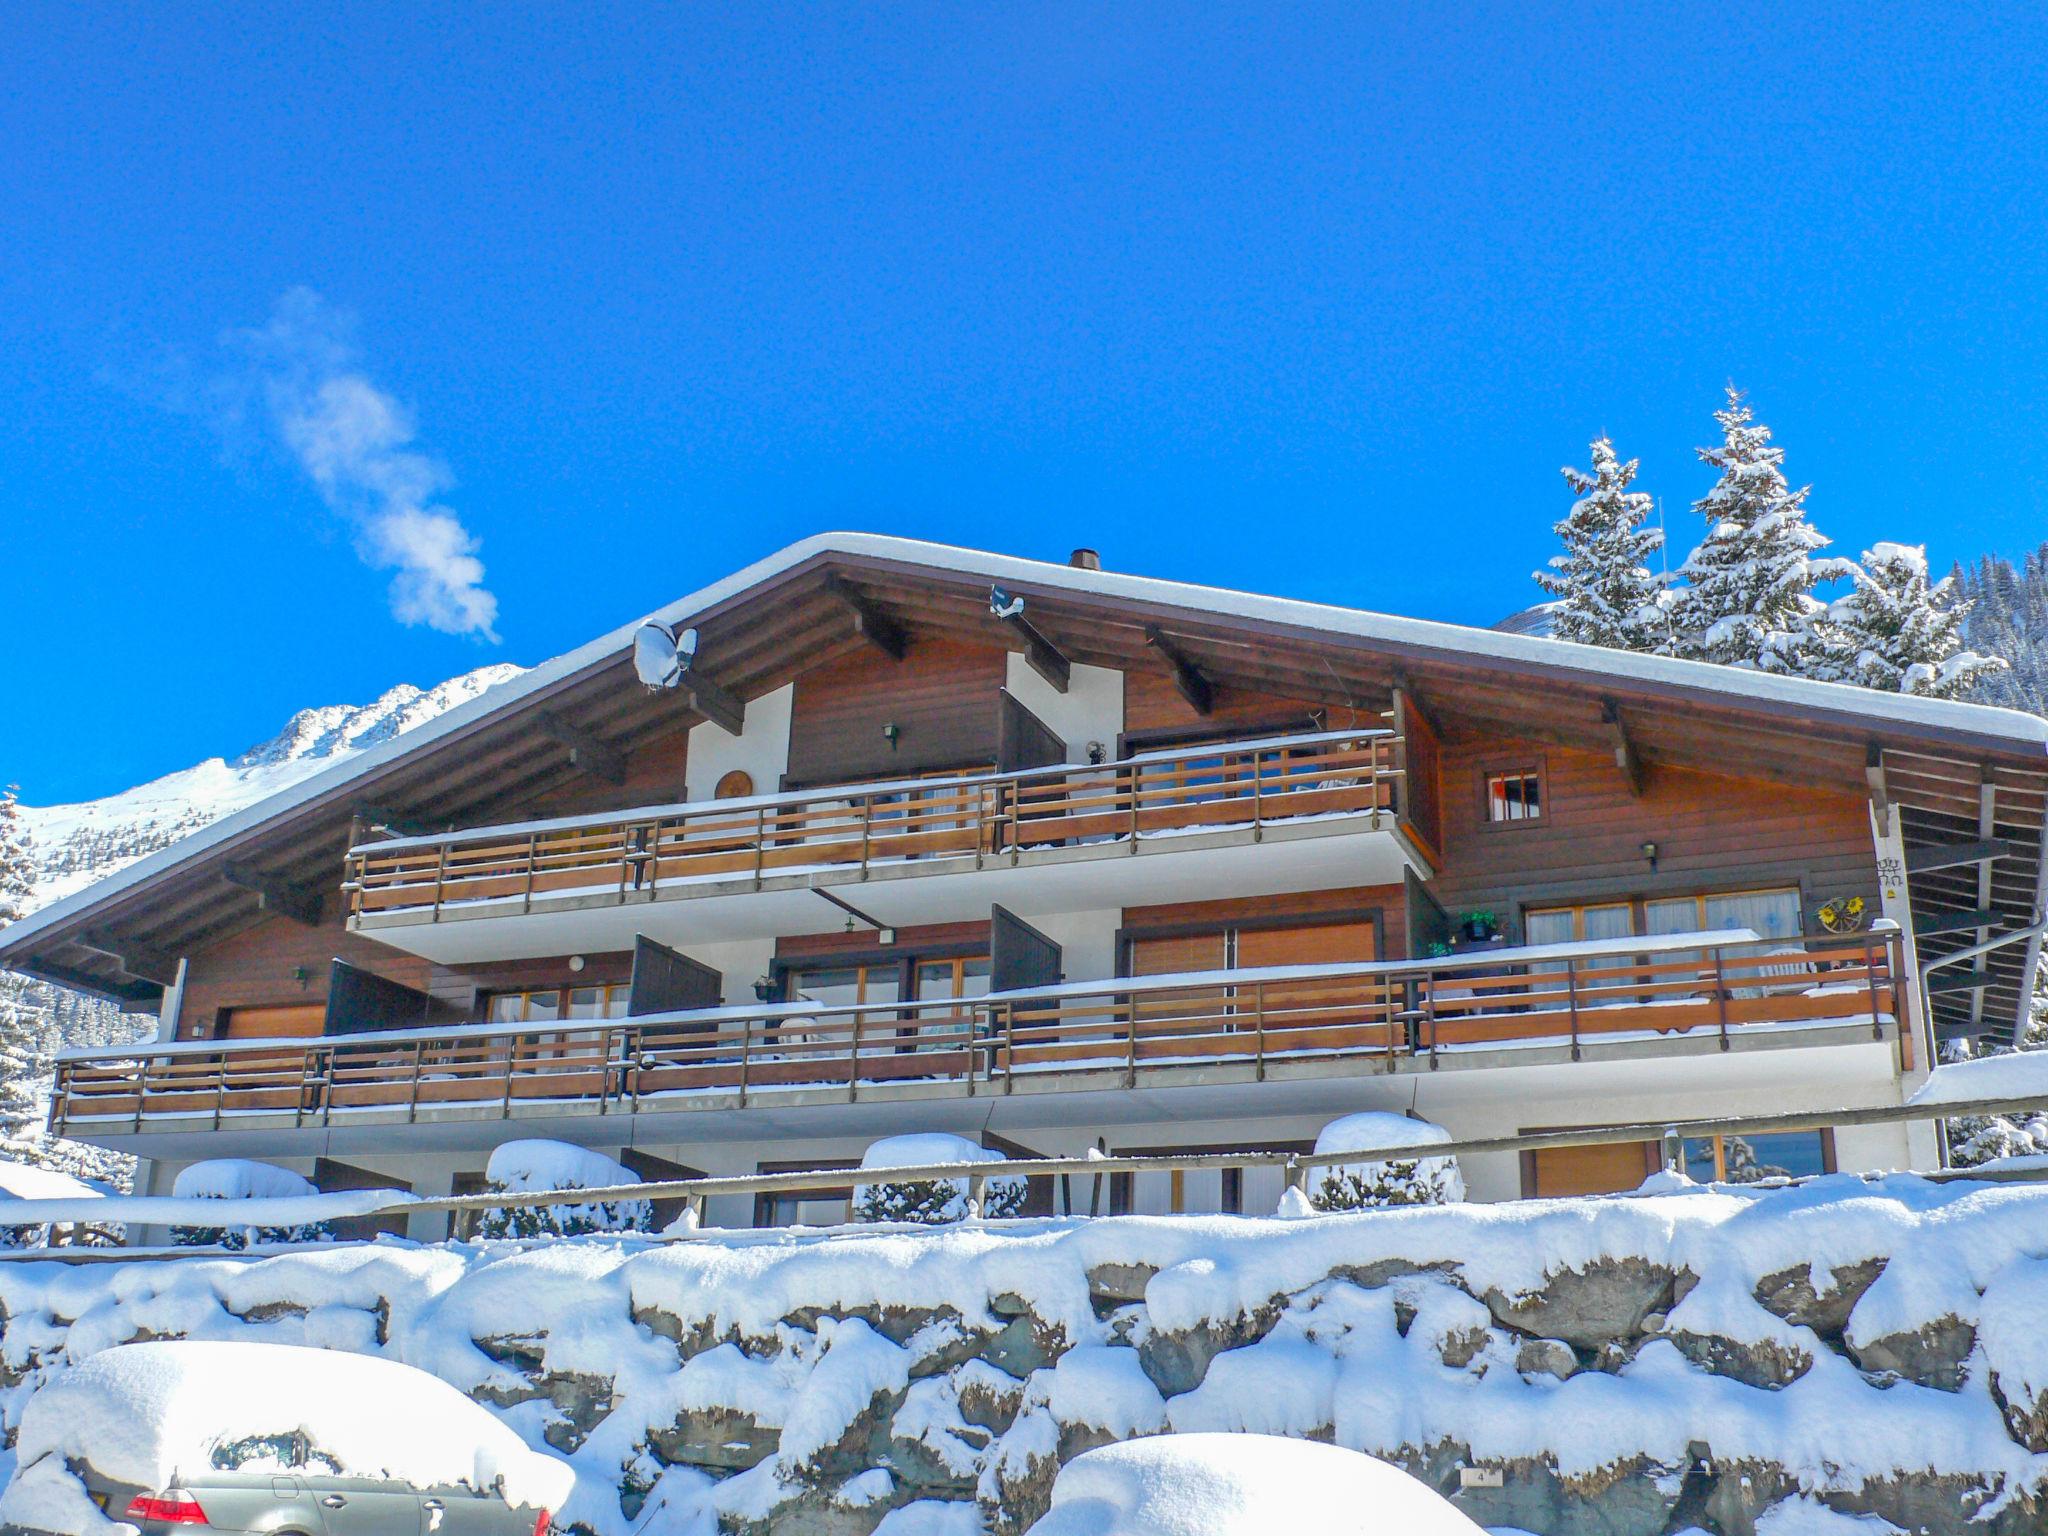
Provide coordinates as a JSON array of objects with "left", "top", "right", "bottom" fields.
[{"left": 0, "top": 1176, "right": 2048, "bottom": 1536}]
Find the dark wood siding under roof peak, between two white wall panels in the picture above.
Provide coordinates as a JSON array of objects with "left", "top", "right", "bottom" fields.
[{"left": 782, "top": 641, "right": 1008, "bottom": 791}]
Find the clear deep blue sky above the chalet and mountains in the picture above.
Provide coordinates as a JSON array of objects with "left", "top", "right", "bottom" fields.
[{"left": 0, "top": 4, "right": 2048, "bottom": 803}]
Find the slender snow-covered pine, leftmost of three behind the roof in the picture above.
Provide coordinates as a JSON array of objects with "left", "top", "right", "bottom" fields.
[{"left": 1536, "top": 434, "right": 1671, "bottom": 653}]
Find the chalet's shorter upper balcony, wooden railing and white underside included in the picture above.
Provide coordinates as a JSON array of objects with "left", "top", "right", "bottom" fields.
[{"left": 344, "top": 729, "right": 1434, "bottom": 963}]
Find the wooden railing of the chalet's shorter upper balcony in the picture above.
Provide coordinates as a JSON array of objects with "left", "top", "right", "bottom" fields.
[{"left": 342, "top": 729, "right": 1401, "bottom": 920}]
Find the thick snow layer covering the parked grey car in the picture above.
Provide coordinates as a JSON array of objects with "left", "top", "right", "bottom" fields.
[{"left": 0, "top": 1341, "right": 573, "bottom": 1536}]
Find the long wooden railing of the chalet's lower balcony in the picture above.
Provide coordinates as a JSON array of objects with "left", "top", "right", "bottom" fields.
[{"left": 51, "top": 932, "right": 1905, "bottom": 1135}]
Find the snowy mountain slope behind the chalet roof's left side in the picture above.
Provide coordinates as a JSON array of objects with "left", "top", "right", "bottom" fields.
[{"left": 20, "top": 664, "right": 522, "bottom": 905}]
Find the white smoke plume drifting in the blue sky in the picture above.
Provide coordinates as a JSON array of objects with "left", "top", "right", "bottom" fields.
[{"left": 229, "top": 289, "right": 498, "bottom": 641}]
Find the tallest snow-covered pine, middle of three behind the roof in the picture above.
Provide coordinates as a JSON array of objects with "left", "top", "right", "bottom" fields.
[{"left": 1673, "top": 385, "right": 1849, "bottom": 674}]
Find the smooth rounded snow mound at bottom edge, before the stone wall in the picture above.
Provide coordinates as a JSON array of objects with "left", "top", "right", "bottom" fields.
[{"left": 1032, "top": 1434, "right": 1481, "bottom": 1536}]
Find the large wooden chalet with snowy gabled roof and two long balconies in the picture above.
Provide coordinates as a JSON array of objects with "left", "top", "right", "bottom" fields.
[{"left": 0, "top": 535, "right": 2048, "bottom": 1221}]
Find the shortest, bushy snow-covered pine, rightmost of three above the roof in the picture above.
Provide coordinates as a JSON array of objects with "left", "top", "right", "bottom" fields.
[{"left": 1808, "top": 545, "right": 2005, "bottom": 698}]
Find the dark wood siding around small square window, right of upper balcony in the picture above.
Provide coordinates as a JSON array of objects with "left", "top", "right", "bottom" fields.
[{"left": 1432, "top": 739, "right": 1878, "bottom": 932}]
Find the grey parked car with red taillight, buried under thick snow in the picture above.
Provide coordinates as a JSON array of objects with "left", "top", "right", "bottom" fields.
[{"left": 0, "top": 1341, "right": 573, "bottom": 1536}]
